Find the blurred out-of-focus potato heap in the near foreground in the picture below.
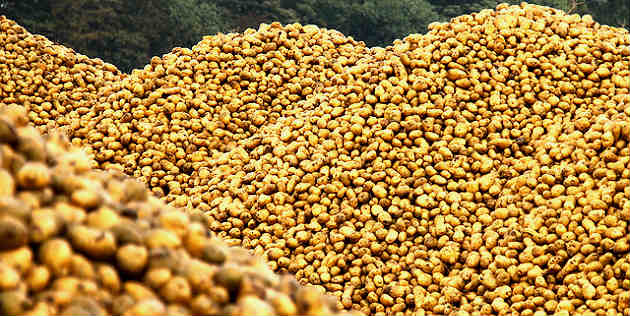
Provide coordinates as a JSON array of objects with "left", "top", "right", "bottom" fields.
[{"left": 0, "top": 106, "right": 360, "bottom": 315}]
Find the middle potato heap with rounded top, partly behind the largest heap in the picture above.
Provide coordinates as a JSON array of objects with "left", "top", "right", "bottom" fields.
[{"left": 84, "top": 23, "right": 367, "bottom": 205}]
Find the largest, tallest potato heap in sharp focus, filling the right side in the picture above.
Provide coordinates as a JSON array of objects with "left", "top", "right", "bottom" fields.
[{"left": 195, "top": 4, "right": 630, "bottom": 315}]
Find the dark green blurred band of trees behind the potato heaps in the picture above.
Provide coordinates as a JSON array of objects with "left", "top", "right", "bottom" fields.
[{"left": 0, "top": 0, "right": 630, "bottom": 72}]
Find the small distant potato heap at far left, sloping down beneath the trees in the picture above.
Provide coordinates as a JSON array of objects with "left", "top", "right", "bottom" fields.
[{"left": 0, "top": 16, "right": 121, "bottom": 138}]
